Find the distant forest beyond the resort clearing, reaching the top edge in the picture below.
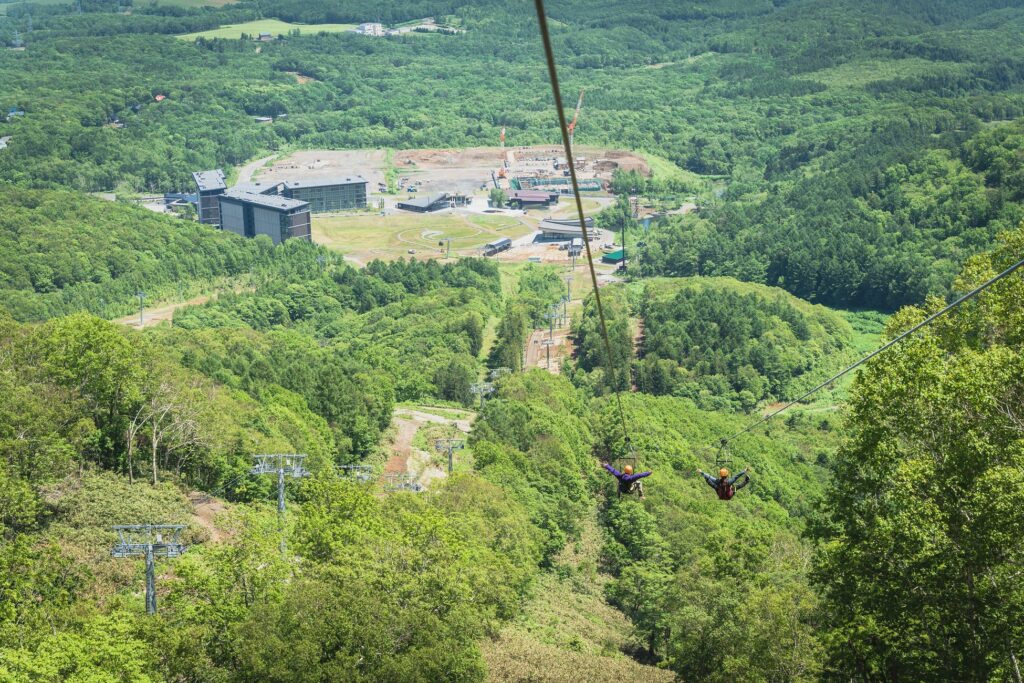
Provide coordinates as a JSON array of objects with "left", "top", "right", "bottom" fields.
[{"left": 6, "top": 0, "right": 1024, "bottom": 310}]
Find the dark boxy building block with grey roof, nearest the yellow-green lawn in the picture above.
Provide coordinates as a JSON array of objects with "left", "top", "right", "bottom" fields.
[{"left": 218, "top": 190, "right": 312, "bottom": 245}]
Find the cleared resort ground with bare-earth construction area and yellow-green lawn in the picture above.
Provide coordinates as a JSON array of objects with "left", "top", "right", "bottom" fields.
[{"left": 243, "top": 145, "right": 650, "bottom": 264}]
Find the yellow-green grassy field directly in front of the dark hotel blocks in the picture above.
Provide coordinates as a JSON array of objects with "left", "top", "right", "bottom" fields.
[{"left": 313, "top": 212, "right": 530, "bottom": 261}]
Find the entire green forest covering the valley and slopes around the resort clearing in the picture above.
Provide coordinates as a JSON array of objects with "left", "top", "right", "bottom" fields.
[{"left": 0, "top": 0, "right": 1024, "bottom": 683}]
